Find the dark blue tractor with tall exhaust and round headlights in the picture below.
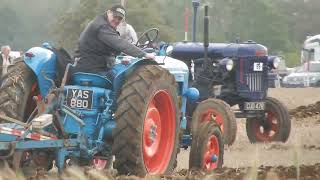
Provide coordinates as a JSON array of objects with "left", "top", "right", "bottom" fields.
[{"left": 171, "top": 4, "right": 291, "bottom": 145}]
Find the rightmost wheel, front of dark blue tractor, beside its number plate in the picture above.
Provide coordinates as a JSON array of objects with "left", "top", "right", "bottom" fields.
[{"left": 246, "top": 97, "right": 291, "bottom": 143}]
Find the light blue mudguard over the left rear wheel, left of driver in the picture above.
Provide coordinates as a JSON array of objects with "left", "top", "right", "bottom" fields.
[{"left": 23, "top": 47, "right": 57, "bottom": 98}]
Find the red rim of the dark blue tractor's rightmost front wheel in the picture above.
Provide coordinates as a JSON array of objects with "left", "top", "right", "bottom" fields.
[{"left": 253, "top": 110, "right": 280, "bottom": 142}]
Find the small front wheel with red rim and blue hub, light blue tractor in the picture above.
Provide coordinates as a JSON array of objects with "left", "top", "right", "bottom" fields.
[{"left": 189, "top": 121, "right": 224, "bottom": 173}]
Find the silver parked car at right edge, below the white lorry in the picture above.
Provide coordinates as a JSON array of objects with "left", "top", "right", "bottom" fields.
[{"left": 283, "top": 61, "right": 320, "bottom": 87}]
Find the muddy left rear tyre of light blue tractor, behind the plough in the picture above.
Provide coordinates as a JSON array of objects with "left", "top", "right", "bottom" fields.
[{"left": 0, "top": 61, "right": 52, "bottom": 171}]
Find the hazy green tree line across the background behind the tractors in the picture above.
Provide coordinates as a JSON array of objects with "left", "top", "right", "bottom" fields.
[{"left": 0, "top": 0, "right": 320, "bottom": 66}]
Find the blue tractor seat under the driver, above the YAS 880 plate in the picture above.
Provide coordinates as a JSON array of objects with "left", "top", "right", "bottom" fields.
[{"left": 72, "top": 72, "right": 112, "bottom": 89}]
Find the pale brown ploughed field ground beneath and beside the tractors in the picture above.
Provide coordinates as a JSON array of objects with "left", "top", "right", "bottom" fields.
[{"left": 0, "top": 88, "right": 320, "bottom": 180}]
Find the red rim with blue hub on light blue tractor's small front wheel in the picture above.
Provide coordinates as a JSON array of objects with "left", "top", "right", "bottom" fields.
[{"left": 202, "top": 135, "right": 220, "bottom": 172}]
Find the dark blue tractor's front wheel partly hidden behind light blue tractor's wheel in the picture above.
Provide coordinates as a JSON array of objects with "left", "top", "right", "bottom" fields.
[{"left": 192, "top": 99, "right": 237, "bottom": 145}]
